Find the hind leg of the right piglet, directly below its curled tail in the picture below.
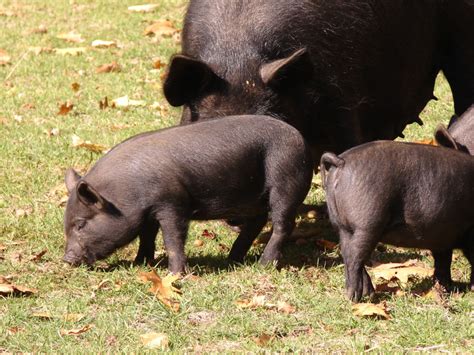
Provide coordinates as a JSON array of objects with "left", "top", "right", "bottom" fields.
[{"left": 339, "top": 230, "right": 377, "bottom": 302}]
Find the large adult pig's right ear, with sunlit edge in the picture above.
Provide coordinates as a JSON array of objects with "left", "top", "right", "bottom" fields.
[{"left": 260, "top": 48, "right": 313, "bottom": 88}]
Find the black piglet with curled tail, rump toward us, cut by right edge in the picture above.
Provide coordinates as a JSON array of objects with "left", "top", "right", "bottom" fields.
[{"left": 320, "top": 141, "right": 474, "bottom": 301}]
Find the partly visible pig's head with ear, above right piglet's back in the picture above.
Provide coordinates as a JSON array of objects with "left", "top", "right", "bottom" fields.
[{"left": 435, "top": 105, "right": 474, "bottom": 155}]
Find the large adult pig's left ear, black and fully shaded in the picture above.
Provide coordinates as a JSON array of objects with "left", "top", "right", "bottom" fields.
[{"left": 163, "top": 54, "right": 220, "bottom": 106}]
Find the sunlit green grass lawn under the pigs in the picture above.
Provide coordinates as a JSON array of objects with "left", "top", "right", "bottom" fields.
[{"left": 0, "top": 0, "right": 474, "bottom": 353}]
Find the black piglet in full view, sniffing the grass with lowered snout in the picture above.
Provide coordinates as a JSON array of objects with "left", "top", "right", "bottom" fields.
[{"left": 64, "top": 116, "right": 313, "bottom": 272}]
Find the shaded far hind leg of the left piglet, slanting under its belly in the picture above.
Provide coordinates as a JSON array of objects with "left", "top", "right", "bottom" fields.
[{"left": 229, "top": 214, "right": 268, "bottom": 262}]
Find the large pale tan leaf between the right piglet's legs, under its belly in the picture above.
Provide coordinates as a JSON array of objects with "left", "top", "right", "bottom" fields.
[{"left": 371, "top": 260, "right": 433, "bottom": 284}]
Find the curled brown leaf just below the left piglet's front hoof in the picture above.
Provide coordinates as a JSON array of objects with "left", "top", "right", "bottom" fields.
[{"left": 139, "top": 269, "right": 181, "bottom": 312}]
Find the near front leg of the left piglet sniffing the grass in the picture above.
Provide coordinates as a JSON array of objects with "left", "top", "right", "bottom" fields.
[{"left": 159, "top": 215, "right": 189, "bottom": 274}]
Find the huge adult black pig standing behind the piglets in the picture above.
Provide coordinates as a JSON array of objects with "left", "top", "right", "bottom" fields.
[{"left": 164, "top": 0, "right": 474, "bottom": 162}]
